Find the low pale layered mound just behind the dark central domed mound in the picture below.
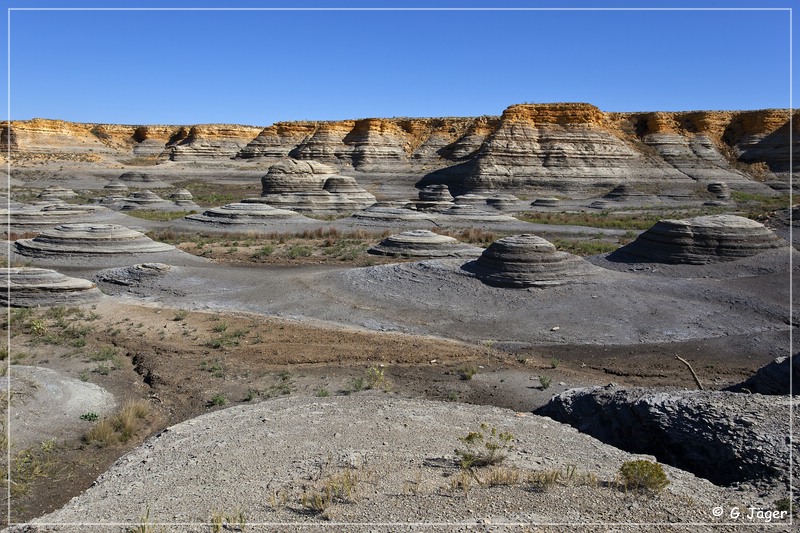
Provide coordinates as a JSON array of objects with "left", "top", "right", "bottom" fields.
[{"left": 368, "top": 230, "right": 483, "bottom": 257}]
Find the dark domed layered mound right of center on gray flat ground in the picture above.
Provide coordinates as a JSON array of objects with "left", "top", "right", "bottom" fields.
[{"left": 463, "top": 234, "right": 597, "bottom": 287}]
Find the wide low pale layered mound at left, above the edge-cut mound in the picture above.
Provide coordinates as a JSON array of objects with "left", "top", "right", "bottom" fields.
[{"left": 15, "top": 224, "right": 175, "bottom": 257}]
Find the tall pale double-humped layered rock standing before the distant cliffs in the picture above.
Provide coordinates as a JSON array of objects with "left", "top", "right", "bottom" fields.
[{"left": 259, "top": 159, "right": 375, "bottom": 215}]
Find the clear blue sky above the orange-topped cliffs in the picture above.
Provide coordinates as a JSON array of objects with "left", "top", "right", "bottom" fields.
[{"left": 0, "top": 0, "right": 800, "bottom": 126}]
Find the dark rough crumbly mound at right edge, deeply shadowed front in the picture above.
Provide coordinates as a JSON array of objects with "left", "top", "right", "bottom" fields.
[{"left": 536, "top": 385, "right": 800, "bottom": 487}]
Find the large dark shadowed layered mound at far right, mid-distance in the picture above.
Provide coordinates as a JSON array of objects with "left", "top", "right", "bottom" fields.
[{"left": 608, "top": 215, "right": 787, "bottom": 265}]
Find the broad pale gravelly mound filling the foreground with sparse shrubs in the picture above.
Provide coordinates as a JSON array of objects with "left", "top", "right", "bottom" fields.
[{"left": 13, "top": 392, "right": 746, "bottom": 532}]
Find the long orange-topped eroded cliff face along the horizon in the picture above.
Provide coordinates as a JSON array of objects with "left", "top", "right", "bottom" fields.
[{"left": 0, "top": 103, "right": 800, "bottom": 192}]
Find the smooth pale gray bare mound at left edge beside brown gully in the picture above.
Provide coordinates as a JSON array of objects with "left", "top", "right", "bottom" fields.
[{"left": 0, "top": 365, "right": 116, "bottom": 449}]
